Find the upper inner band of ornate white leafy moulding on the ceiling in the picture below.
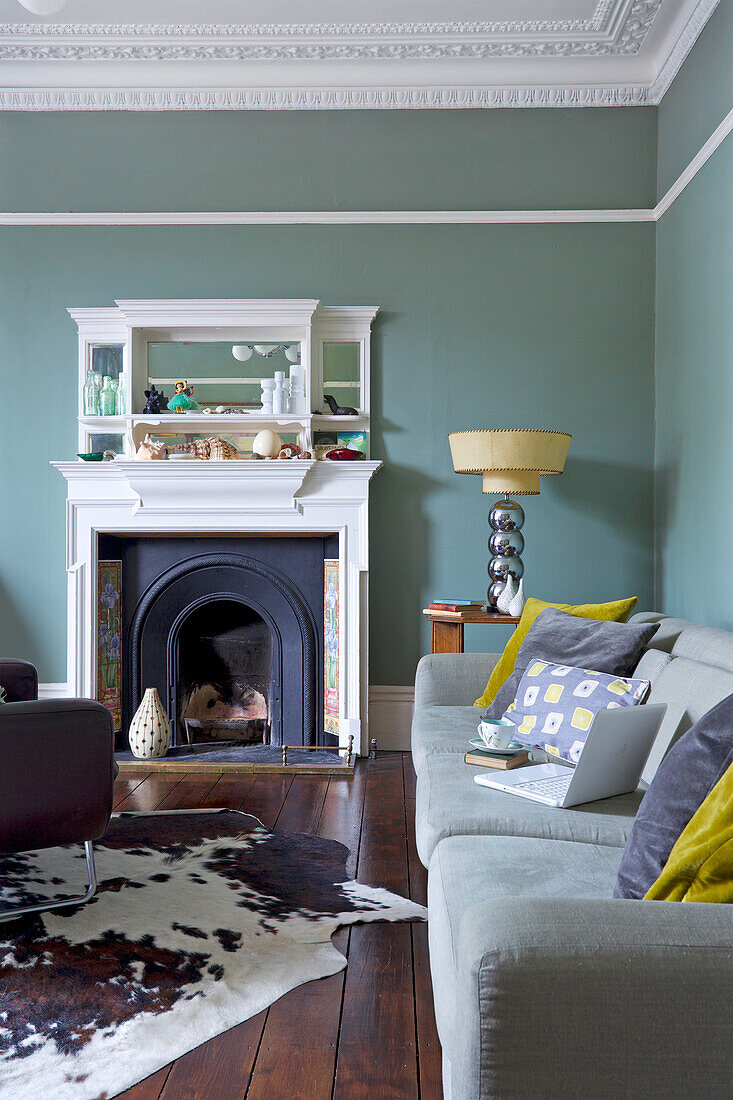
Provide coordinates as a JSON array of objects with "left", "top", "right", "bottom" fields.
[{"left": 0, "top": 0, "right": 661, "bottom": 62}]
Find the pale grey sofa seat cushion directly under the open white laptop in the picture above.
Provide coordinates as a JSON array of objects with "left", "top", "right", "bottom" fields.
[{"left": 415, "top": 754, "right": 643, "bottom": 867}]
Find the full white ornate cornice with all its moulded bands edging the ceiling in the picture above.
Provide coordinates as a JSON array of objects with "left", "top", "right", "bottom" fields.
[{"left": 0, "top": 0, "right": 719, "bottom": 111}]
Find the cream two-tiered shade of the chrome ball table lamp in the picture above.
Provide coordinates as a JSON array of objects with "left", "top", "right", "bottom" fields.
[{"left": 448, "top": 428, "right": 571, "bottom": 496}]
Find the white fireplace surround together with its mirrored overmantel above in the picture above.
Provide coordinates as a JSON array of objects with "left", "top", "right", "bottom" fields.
[{"left": 54, "top": 299, "right": 381, "bottom": 752}]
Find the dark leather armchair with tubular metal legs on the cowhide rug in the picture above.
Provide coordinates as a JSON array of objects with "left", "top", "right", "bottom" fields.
[{"left": 0, "top": 659, "right": 116, "bottom": 917}]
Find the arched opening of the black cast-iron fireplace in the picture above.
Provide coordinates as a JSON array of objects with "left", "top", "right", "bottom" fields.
[{"left": 174, "top": 598, "right": 276, "bottom": 745}]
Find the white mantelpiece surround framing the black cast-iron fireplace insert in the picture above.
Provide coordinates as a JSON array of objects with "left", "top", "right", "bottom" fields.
[{"left": 54, "top": 459, "right": 382, "bottom": 754}]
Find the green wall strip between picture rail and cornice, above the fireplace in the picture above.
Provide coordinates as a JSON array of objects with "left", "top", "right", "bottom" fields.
[{"left": 0, "top": 108, "right": 656, "bottom": 210}]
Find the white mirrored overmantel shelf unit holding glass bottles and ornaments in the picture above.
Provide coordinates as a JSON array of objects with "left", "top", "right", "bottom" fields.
[{"left": 68, "top": 299, "right": 378, "bottom": 458}]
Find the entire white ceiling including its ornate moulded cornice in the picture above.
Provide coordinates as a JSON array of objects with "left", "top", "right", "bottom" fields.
[{"left": 0, "top": 0, "right": 719, "bottom": 110}]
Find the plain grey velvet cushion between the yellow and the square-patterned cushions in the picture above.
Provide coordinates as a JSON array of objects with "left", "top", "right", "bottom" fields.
[{"left": 488, "top": 607, "right": 658, "bottom": 718}]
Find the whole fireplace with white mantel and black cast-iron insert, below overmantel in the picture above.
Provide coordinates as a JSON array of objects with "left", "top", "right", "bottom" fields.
[{"left": 55, "top": 459, "right": 381, "bottom": 754}]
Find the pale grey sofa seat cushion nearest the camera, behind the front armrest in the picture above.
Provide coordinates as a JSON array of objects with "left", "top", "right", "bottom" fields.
[{"left": 428, "top": 836, "right": 620, "bottom": 1057}]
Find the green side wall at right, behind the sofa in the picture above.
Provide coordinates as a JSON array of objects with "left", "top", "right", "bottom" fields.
[{"left": 655, "top": 0, "right": 733, "bottom": 629}]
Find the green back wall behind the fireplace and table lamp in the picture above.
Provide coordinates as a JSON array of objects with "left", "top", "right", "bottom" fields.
[{"left": 0, "top": 111, "right": 655, "bottom": 684}]
